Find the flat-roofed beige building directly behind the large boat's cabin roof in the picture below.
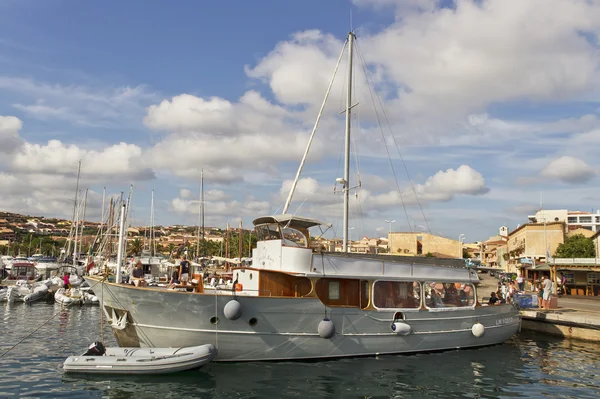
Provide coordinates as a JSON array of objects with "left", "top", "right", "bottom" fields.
[{"left": 388, "top": 233, "right": 462, "bottom": 258}]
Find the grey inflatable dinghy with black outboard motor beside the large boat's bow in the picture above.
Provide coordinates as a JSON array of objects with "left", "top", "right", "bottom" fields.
[{"left": 63, "top": 342, "right": 217, "bottom": 374}]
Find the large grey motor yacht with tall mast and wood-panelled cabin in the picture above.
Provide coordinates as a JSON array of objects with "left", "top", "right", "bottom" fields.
[{"left": 89, "top": 32, "right": 521, "bottom": 362}]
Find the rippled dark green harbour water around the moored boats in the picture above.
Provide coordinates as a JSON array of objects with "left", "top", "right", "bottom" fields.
[{"left": 0, "top": 303, "right": 600, "bottom": 398}]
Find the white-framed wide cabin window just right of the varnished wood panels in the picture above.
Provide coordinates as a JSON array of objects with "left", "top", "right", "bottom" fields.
[{"left": 373, "top": 281, "right": 421, "bottom": 309}]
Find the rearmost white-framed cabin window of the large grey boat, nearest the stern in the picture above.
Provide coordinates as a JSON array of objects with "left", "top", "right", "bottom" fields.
[{"left": 425, "top": 281, "right": 475, "bottom": 309}]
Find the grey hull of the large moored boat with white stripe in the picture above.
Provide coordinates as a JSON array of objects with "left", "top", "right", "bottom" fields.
[{"left": 89, "top": 280, "right": 521, "bottom": 361}]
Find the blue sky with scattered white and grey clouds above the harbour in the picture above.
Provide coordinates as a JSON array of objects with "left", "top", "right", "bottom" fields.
[{"left": 0, "top": 0, "right": 600, "bottom": 242}]
